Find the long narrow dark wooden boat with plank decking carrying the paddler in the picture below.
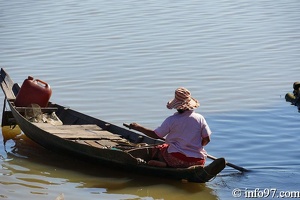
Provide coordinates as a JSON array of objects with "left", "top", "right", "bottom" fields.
[{"left": 0, "top": 68, "right": 226, "bottom": 183}]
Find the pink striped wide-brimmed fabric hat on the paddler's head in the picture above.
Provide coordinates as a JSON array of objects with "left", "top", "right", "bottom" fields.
[{"left": 167, "top": 87, "right": 200, "bottom": 110}]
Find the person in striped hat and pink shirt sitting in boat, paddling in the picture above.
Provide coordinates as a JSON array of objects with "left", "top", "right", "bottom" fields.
[{"left": 129, "top": 87, "right": 212, "bottom": 168}]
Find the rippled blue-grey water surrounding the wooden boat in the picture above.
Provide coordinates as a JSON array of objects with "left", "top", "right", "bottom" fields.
[{"left": 0, "top": 0, "right": 300, "bottom": 200}]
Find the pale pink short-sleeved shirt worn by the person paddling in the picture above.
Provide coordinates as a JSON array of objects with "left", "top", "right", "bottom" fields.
[{"left": 154, "top": 110, "right": 211, "bottom": 159}]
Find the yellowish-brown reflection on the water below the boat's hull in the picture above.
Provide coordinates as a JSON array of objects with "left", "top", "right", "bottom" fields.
[{"left": 0, "top": 127, "right": 217, "bottom": 200}]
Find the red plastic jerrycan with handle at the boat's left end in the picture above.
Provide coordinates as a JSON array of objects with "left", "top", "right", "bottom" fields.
[{"left": 15, "top": 76, "right": 52, "bottom": 107}]
